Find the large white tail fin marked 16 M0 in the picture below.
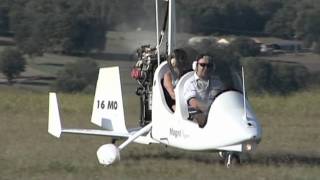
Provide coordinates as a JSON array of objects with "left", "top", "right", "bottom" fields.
[{"left": 91, "top": 67, "right": 128, "bottom": 133}]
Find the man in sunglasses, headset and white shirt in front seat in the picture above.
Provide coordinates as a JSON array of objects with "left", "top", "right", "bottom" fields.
[{"left": 183, "top": 55, "right": 223, "bottom": 128}]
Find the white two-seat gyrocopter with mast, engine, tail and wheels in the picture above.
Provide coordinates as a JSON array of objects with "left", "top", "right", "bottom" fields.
[{"left": 48, "top": 0, "right": 261, "bottom": 167}]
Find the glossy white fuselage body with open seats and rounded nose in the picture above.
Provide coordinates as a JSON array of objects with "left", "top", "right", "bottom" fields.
[{"left": 151, "top": 63, "right": 261, "bottom": 151}]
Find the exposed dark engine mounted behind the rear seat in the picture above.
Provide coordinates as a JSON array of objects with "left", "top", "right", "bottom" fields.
[{"left": 131, "top": 45, "right": 166, "bottom": 127}]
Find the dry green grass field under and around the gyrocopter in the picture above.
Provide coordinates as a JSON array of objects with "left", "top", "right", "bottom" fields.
[{"left": 0, "top": 87, "right": 320, "bottom": 180}]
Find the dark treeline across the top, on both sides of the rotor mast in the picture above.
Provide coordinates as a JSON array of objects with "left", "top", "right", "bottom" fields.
[{"left": 0, "top": 0, "right": 320, "bottom": 55}]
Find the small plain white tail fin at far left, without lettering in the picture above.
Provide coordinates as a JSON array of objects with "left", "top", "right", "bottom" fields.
[{"left": 48, "top": 92, "right": 61, "bottom": 138}]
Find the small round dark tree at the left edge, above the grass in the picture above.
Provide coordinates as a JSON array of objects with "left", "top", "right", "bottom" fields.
[{"left": 0, "top": 48, "right": 26, "bottom": 84}]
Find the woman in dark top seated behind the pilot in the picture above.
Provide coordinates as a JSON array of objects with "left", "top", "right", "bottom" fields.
[{"left": 163, "top": 49, "right": 187, "bottom": 111}]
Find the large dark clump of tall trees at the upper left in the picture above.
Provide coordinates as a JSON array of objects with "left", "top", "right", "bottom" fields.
[{"left": 10, "top": 0, "right": 110, "bottom": 56}]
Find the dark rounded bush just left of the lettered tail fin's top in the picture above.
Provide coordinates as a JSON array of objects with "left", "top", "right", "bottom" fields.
[{"left": 54, "top": 60, "right": 98, "bottom": 92}]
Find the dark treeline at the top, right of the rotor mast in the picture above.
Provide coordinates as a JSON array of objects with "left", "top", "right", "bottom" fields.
[{"left": 179, "top": 0, "right": 320, "bottom": 49}]
